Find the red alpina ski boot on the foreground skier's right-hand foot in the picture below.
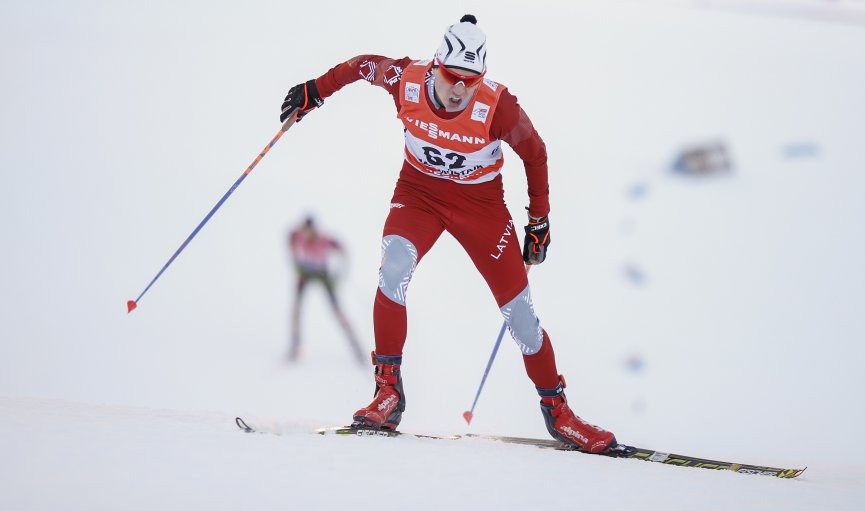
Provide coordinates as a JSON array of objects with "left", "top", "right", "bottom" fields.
[{"left": 536, "top": 375, "right": 618, "bottom": 453}]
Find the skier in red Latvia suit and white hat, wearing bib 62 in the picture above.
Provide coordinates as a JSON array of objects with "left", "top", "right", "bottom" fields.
[{"left": 280, "top": 14, "right": 616, "bottom": 452}]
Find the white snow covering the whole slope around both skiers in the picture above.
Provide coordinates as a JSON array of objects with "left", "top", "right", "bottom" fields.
[{"left": 0, "top": 0, "right": 865, "bottom": 510}]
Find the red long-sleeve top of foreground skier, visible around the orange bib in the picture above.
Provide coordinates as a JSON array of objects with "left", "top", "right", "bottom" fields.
[{"left": 315, "top": 55, "right": 550, "bottom": 217}]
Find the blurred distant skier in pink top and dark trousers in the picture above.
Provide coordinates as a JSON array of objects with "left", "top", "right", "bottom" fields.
[{"left": 288, "top": 216, "right": 364, "bottom": 363}]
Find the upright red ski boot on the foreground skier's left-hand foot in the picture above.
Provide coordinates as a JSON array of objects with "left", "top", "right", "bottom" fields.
[{"left": 351, "top": 351, "right": 405, "bottom": 429}]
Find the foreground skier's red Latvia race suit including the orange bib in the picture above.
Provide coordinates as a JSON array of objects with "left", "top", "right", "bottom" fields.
[{"left": 316, "top": 55, "right": 559, "bottom": 388}]
